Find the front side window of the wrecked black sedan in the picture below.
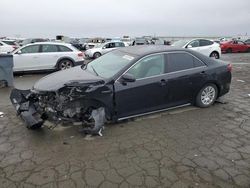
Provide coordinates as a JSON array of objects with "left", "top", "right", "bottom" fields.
[{"left": 128, "top": 54, "right": 165, "bottom": 79}]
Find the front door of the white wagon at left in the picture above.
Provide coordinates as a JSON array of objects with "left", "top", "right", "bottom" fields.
[{"left": 13, "top": 44, "right": 40, "bottom": 71}]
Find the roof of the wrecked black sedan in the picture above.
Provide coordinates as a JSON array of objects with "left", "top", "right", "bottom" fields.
[{"left": 118, "top": 45, "right": 192, "bottom": 56}]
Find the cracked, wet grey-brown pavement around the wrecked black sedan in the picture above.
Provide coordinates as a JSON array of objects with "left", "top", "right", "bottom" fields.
[{"left": 0, "top": 54, "right": 250, "bottom": 188}]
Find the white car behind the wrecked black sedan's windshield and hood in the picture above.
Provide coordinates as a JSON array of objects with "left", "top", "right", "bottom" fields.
[{"left": 85, "top": 41, "right": 125, "bottom": 59}]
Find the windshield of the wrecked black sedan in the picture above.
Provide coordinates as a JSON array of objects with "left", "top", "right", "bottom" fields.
[{"left": 87, "top": 51, "right": 135, "bottom": 78}]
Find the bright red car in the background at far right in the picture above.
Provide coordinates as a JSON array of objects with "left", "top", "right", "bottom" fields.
[{"left": 220, "top": 40, "right": 250, "bottom": 53}]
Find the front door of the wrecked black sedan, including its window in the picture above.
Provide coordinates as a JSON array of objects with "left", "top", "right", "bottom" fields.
[{"left": 114, "top": 54, "right": 167, "bottom": 119}]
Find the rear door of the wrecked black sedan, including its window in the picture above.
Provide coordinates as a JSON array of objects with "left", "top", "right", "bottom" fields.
[{"left": 166, "top": 52, "right": 206, "bottom": 107}]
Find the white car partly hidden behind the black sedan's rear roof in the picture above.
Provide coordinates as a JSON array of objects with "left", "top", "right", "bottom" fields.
[{"left": 171, "top": 39, "right": 221, "bottom": 59}]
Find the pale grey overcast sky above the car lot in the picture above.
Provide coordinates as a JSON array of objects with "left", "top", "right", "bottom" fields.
[{"left": 0, "top": 0, "right": 250, "bottom": 38}]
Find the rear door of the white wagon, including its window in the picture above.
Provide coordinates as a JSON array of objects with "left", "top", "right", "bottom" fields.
[{"left": 39, "top": 44, "right": 60, "bottom": 69}]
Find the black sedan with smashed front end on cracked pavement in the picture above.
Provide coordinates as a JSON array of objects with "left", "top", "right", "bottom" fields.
[{"left": 10, "top": 46, "right": 232, "bottom": 134}]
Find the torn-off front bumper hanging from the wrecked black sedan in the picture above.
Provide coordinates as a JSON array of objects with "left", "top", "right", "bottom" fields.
[{"left": 10, "top": 89, "right": 44, "bottom": 129}]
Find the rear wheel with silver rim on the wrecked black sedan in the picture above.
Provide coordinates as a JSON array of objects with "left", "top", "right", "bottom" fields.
[{"left": 196, "top": 84, "right": 218, "bottom": 108}]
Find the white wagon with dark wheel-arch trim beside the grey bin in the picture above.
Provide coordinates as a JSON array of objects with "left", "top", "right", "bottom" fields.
[{"left": 13, "top": 42, "right": 84, "bottom": 72}]
